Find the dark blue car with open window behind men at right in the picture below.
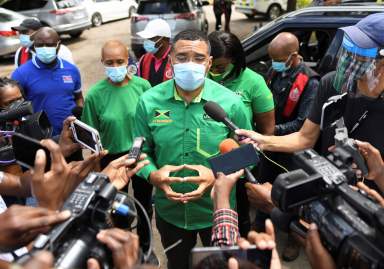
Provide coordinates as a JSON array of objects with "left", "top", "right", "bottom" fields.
[{"left": 242, "top": 4, "right": 384, "bottom": 77}]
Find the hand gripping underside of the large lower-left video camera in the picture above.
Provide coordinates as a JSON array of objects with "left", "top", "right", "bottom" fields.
[{"left": 88, "top": 228, "right": 139, "bottom": 269}]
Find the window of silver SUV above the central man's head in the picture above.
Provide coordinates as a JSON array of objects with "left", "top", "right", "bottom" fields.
[{"left": 137, "top": 0, "right": 190, "bottom": 14}]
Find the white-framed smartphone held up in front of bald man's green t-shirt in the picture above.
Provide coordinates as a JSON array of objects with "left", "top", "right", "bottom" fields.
[{"left": 71, "top": 120, "right": 103, "bottom": 154}]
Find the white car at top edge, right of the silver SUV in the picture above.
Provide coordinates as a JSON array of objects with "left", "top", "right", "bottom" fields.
[{"left": 235, "top": 0, "right": 287, "bottom": 20}]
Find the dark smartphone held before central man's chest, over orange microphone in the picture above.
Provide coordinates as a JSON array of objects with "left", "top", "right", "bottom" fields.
[{"left": 208, "top": 144, "right": 260, "bottom": 175}]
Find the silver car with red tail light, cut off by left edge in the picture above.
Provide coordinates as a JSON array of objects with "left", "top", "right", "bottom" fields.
[{"left": 0, "top": 8, "right": 27, "bottom": 56}]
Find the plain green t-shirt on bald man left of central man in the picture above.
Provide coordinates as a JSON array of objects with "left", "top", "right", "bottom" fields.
[{"left": 81, "top": 76, "right": 151, "bottom": 154}]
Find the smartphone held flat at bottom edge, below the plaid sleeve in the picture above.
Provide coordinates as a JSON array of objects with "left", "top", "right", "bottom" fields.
[{"left": 190, "top": 246, "right": 272, "bottom": 269}]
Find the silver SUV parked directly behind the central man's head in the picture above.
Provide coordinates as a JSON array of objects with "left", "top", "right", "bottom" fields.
[{"left": 131, "top": 0, "right": 209, "bottom": 58}]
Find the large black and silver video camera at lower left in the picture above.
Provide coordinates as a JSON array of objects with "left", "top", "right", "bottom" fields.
[{"left": 18, "top": 173, "right": 137, "bottom": 269}]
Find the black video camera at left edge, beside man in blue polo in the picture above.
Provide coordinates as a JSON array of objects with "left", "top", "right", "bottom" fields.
[{"left": 0, "top": 100, "right": 52, "bottom": 164}]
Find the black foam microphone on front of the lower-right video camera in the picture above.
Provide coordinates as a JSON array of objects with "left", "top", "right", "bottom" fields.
[{"left": 271, "top": 207, "right": 307, "bottom": 238}]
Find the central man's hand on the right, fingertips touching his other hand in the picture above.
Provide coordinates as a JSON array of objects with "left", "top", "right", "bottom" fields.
[{"left": 182, "top": 164, "right": 215, "bottom": 203}]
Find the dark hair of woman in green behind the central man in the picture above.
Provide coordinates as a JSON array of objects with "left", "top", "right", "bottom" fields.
[{"left": 208, "top": 31, "right": 247, "bottom": 77}]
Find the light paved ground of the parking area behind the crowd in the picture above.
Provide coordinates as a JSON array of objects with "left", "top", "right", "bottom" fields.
[{"left": 0, "top": 6, "right": 309, "bottom": 269}]
